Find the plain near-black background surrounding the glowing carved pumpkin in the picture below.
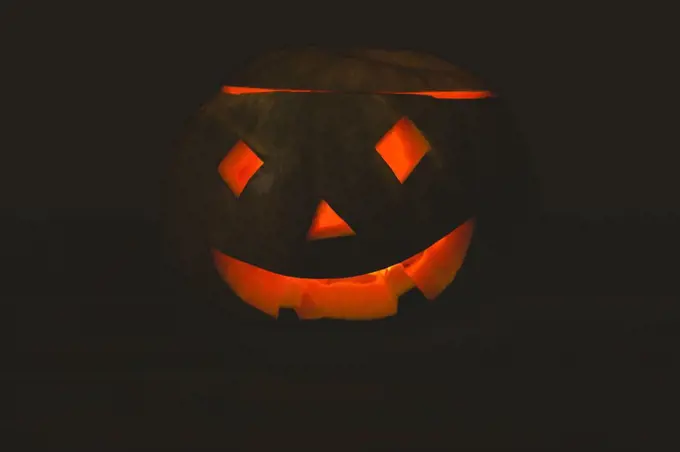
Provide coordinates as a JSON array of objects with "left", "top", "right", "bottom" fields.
[{"left": 6, "top": 2, "right": 680, "bottom": 450}]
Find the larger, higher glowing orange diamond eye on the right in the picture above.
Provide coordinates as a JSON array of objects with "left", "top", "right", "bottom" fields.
[{"left": 375, "top": 118, "right": 430, "bottom": 184}]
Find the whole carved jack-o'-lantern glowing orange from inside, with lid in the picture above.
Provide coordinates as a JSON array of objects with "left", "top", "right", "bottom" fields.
[{"left": 165, "top": 49, "right": 532, "bottom": 328}]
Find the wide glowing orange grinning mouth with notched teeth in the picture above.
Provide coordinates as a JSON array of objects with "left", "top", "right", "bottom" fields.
[{"left": 213, "top": 219, "right": 474, "bottom": 320}]
